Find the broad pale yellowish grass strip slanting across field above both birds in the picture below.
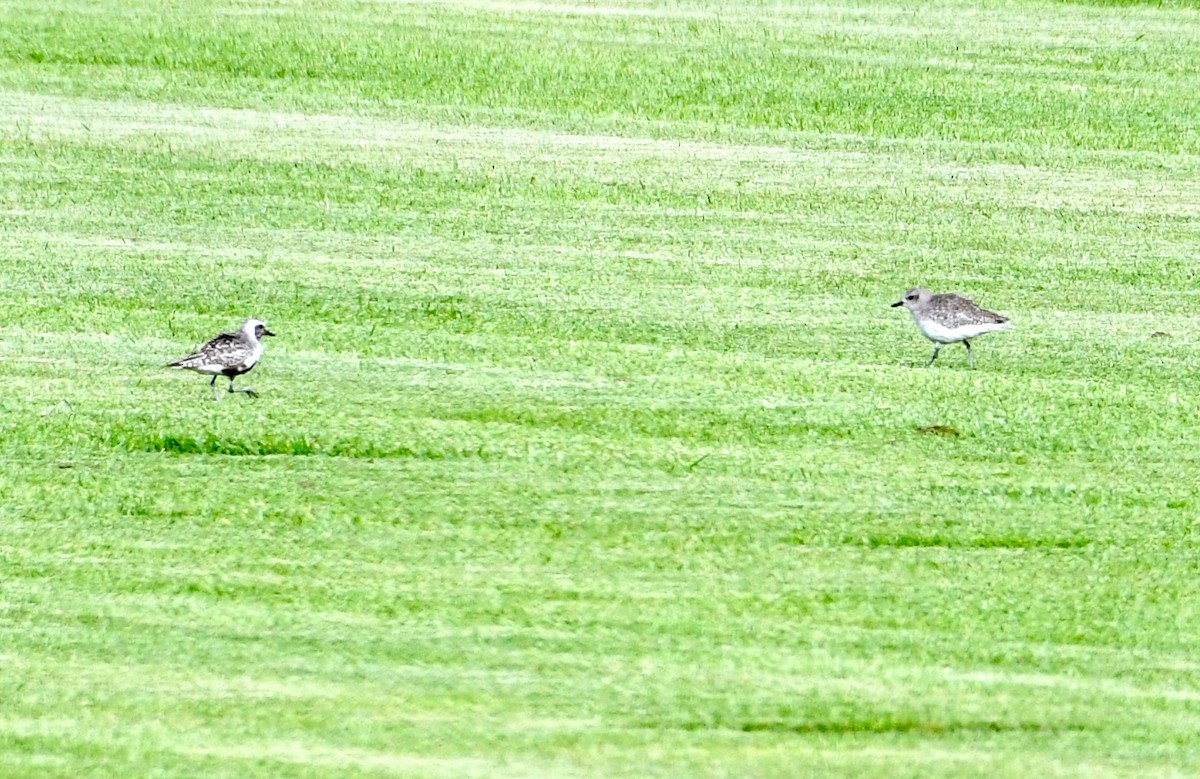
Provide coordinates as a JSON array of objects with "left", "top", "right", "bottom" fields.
[{"left": 9, "top": 92, "right": 1200, "bottom": 220}]
